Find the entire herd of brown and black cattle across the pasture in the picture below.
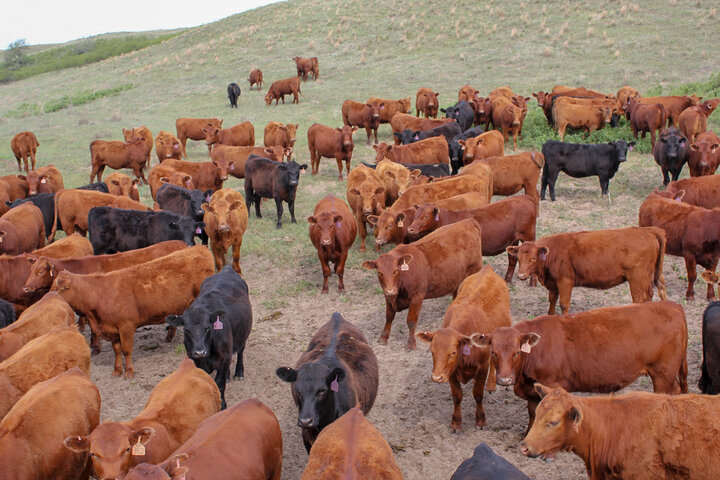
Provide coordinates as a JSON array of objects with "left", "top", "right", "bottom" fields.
[{"left": 0, "top": 62, "right": 720, "bottom": 480}]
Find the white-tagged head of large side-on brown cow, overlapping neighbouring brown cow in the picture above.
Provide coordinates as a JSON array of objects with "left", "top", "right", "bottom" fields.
[{"left": 470, "top": 327, "right": 540, "bottom": 387}]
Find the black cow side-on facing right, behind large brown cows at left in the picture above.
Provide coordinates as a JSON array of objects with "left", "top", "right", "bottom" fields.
[{"left": 88, "top": 207, "right": 205, "bottom": 255}]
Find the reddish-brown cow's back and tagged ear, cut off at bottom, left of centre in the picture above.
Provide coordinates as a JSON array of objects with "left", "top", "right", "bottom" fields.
[{"left": 123, "top": 398, "right": 282, "bottom": 480}]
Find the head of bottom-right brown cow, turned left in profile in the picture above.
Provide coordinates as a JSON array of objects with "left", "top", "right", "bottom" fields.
[{"left": 520, "top": 383, "right": 585, "bottom": 458}]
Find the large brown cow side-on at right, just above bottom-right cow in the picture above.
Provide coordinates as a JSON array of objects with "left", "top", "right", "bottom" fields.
[{"left": 471, "top": 301, "right": 688, "bottom": 432}]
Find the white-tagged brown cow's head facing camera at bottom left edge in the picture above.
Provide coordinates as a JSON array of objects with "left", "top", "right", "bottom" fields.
[{"left": 64, "top": 422, "right": 155, "bottom": 480}]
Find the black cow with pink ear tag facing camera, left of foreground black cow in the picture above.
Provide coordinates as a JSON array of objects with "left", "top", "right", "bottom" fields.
[{"left": 166, "top": 265, "right": 252, "bottom": 409}]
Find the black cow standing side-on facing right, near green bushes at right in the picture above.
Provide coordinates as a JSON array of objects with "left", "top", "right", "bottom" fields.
[{"left": 540, "top": 140, "right": 635, "bottom": 202}]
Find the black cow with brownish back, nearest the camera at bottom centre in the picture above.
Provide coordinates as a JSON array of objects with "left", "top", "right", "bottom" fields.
[{"left": 275, "top": 312, "right": 378, "bottom": 453}]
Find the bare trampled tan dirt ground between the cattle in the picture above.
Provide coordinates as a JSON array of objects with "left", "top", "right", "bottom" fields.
[{"left": 86, "top": 151, "right": 707, "bottom": 479}]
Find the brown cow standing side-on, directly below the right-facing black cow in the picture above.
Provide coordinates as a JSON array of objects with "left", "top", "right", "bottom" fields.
[{"left": 507, "top": 227, "right": 667, "bottom": 315}]
